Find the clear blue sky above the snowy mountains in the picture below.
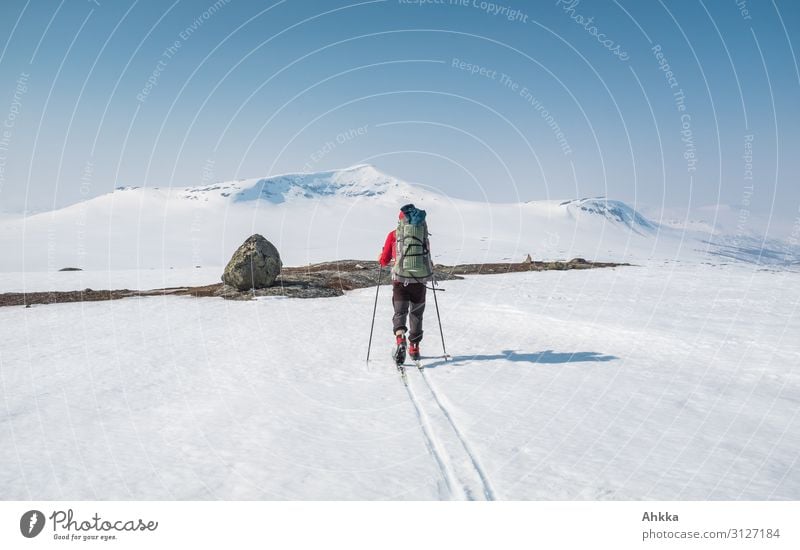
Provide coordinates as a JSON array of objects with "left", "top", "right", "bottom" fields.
[{"left": 0, "top": 0, "right": 800, "bottom": 233}]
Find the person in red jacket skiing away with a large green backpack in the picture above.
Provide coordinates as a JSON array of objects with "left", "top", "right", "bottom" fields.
[{"left": 378, "top": 204, "right": 433, "bottom": 366}]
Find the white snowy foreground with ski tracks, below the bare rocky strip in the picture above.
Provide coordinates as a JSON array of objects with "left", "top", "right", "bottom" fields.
[{"left": 0, "top": 262, "right": 800, "bottom": 500}]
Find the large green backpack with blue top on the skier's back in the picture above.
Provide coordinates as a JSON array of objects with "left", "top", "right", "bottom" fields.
[{"left": 392, "top": 204, "right": 433, "bottom": 283}]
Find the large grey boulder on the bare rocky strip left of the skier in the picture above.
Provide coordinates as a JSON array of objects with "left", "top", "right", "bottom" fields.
[{"left": 222, "top": 235, "right": 282, "bottom": 290}]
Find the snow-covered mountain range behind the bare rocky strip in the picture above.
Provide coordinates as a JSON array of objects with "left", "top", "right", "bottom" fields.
[{"left": 0, "top": 165, "right": 800, "bottom": 271}]
